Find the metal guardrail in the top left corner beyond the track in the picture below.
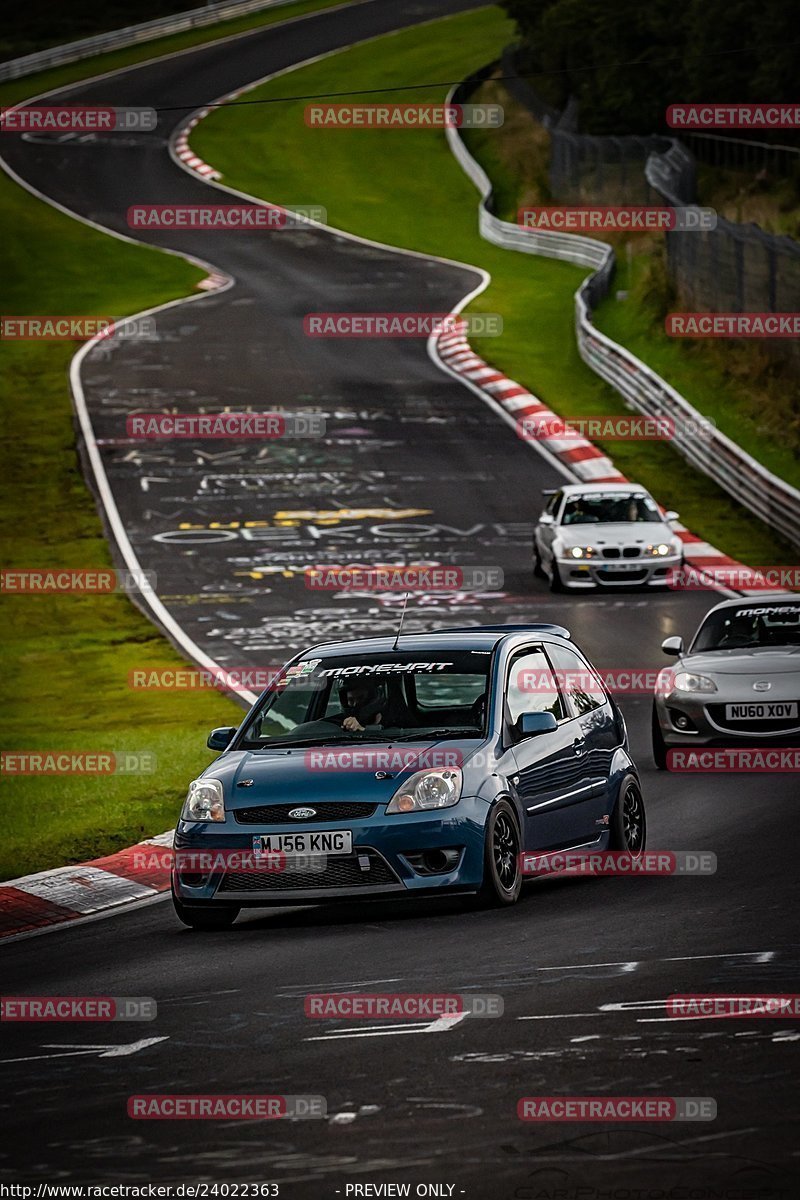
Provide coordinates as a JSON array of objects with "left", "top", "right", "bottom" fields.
[{"left": 0, "top": 0, "right": 307, "bottom": 80}]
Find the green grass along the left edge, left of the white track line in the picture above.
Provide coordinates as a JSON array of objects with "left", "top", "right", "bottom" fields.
[{"left": 0, "top": 152, "right": 240, "bottom": 878}]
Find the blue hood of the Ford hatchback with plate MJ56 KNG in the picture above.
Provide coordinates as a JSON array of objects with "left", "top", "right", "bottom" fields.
[{"left": 204, "top": 738, "right": 483, "bottom": 809}]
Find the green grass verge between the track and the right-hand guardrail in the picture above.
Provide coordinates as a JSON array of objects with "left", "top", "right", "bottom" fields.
[{"left": 192, "top": 7, "right": 792, "bottom": 564}]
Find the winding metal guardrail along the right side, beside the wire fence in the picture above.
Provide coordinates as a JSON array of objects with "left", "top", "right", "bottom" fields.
[{"left": 446, "top": 77, "right": 800, "bottom": 547}]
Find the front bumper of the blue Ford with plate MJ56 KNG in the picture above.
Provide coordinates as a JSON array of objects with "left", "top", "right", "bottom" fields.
[{"left": 173, "top": 797, "right": 489, "bottom": 907}]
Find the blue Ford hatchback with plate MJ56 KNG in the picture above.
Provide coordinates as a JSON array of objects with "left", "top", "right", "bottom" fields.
[{"left": 173, "top": 624, "right": 645, "bottom": 929}]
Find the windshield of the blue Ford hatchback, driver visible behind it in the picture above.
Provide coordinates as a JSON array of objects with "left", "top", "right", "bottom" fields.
[{"left": 239, "top": 650, "right": 491, "bottom": 750}]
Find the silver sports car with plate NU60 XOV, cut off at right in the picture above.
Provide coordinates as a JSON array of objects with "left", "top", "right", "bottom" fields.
[{"left": 652, "top": 593, "right": 800, "bottom": 770}]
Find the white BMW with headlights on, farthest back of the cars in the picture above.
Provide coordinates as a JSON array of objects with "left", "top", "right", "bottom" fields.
[{"left": 534, "top": 484, "right": 682, "bottom": 592}]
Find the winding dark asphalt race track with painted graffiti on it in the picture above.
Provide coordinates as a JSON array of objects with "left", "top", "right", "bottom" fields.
[{"left": 0, "top": 0, "right": 800, "bottom": 1200}]
